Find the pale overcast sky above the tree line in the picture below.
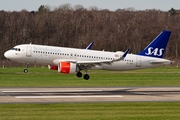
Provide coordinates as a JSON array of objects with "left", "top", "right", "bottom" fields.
[{"left": 0, "top": 0, "right": 180, "bottom": 11}]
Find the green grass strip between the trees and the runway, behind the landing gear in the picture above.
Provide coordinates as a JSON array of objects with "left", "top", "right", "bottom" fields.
[{"left": 0, "top": 67, "right": 180, "bottom": 87}]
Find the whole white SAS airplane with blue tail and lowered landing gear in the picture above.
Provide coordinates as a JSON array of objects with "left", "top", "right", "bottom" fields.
[{"left": 4, "top": 30, "right": 172, "bottom": 80}]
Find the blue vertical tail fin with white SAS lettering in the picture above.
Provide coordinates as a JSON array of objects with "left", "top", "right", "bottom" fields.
[{"left": 138, "top": 30, "right": 171, "bottom": 58}]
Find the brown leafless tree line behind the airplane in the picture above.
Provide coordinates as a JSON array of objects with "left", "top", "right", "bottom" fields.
[{"left": 0, "top": 4, "right": 180, "bottom": 59}]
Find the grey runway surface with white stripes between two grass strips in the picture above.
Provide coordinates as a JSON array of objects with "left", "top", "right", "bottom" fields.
[{"left": 0, "top": 87, "right": 180, "bottom": 103}]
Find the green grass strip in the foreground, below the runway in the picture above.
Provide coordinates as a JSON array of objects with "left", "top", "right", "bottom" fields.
[{"left": 0, "top": 102, "right": 180, "bottom": 120}]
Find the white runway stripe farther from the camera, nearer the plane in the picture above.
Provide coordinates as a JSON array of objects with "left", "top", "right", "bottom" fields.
[{"left": 2, "top": 90, "right": 103, "bottom": 93}]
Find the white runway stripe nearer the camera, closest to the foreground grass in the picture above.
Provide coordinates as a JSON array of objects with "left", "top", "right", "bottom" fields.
[{"left": 15, "top": 95, "right": 123, "bottom": 99}]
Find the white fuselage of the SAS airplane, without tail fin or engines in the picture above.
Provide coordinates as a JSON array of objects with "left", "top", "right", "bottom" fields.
[{"left": 4, "top": 44, "right": 171, "bottom": 70}]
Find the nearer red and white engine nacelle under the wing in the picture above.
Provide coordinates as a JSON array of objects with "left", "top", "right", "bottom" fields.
[{"left": 58, "top": 62, "right": 78, "bottom": 74}]
